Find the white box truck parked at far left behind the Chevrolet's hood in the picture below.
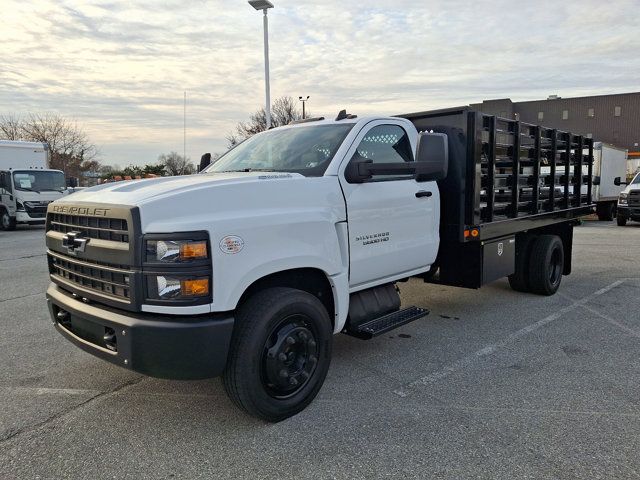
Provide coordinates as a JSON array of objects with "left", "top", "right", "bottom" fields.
[{"left": 0, "top": 140, "right": 65, "bottom": 230}]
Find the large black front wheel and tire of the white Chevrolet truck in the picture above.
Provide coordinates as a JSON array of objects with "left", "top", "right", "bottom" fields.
[{"left": 222, "top": 287, "right": 333, "bottom": 422}]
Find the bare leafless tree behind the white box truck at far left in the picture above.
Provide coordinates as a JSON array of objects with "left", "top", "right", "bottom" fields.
[{"left": 0, "top": 113, "right": 98, "bottom": 177}]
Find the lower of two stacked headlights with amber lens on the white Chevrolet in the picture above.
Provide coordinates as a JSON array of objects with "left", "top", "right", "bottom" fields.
[{"left": 147, "top": 275, "right": 211, "bottom": 302}]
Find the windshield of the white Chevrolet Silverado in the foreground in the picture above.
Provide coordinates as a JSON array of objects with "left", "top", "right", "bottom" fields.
[{"left": 204, "top": 123, "right": 353, "bottom": 177}]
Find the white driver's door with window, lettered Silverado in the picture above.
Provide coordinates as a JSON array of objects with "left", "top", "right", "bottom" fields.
[{"left": 339, "top": 120, "right": 440, "bottom": 287}]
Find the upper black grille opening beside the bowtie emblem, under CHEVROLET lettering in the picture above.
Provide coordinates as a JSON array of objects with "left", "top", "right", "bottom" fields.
[{"left": 49, "top": 213, "right": 129, "bottom": 243}]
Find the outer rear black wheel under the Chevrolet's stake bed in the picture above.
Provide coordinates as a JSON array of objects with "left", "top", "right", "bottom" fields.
[{"left": 529, "top": 235, "right": 564, "bottom": 295}]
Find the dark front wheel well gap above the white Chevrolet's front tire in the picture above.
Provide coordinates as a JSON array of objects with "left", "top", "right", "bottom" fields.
[{"left": 238, "top": 268, "right": 335, "bottom": 326}]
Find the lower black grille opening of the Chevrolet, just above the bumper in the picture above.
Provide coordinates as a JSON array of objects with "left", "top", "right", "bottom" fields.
[{"left": 48, "top": 252, "right": 131, "bottom": 301}]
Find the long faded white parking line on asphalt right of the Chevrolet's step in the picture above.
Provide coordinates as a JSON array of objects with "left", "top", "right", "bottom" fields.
[{"left": 393, "top": 279, "right": 626, "bottom": 397}]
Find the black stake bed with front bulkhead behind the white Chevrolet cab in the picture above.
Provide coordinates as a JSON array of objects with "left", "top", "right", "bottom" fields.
[{"left": 399, "top": 107, "right": 594, "bottom": 287}]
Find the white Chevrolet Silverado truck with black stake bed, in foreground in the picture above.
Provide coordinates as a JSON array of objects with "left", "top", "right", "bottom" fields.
[{"left": 46, "top": 108, "right": 593, "bottom": 421}]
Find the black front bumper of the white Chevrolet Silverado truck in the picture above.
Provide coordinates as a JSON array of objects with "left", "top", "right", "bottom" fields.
[{"left": 47, "top": 284, "right": 234, "bottom": 380}]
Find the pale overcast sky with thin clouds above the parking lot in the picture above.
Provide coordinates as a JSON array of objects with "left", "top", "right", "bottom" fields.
[{"left": 0, "top": 0, "right": 640, "bottom": 167}]
